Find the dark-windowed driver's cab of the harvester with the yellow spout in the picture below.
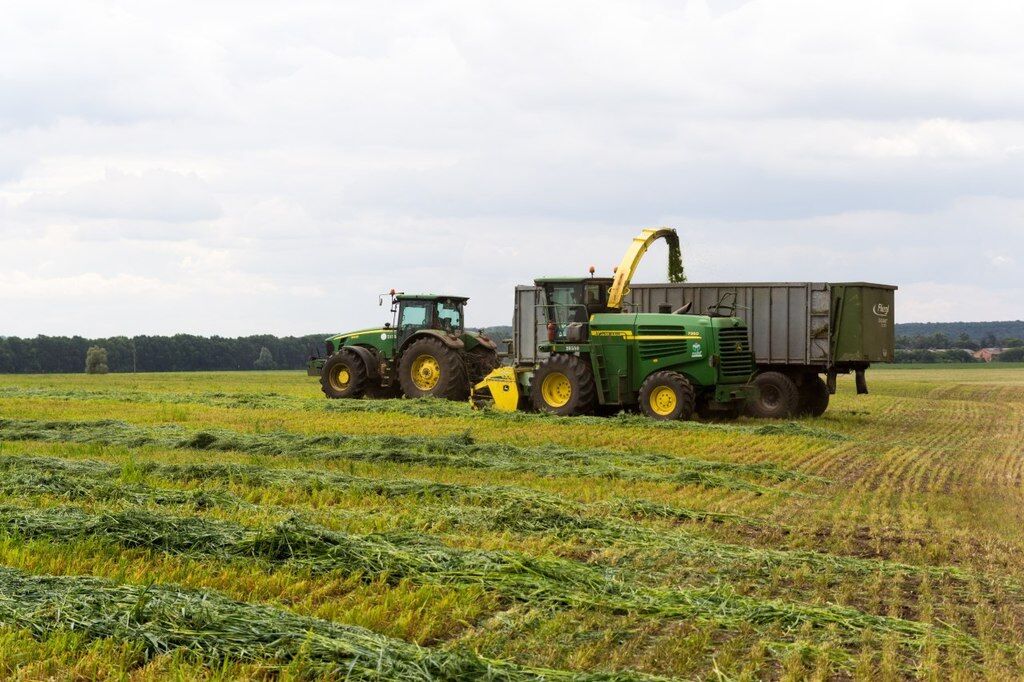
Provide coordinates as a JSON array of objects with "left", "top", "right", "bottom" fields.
[{"left": 534, "top": 276, "right": 617, "bottom": 343}]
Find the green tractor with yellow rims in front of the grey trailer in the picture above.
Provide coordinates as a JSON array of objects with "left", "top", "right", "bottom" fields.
[{"left": 308, "top": 290, "right": 499, "bottom": 400}]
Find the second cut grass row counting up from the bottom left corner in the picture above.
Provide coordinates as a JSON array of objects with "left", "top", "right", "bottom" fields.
[{"left": 0, "top": 499, "right": 980, "bottom": 663}]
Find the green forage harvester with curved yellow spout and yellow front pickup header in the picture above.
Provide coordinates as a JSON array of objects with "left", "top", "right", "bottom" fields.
[{"left": 473, "top": 228, "right": 754, "bottom": 420}]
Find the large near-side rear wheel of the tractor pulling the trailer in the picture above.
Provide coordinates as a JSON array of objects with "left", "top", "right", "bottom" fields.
[{"left": 398, "top": 336, "right": 469, "bottom": 400}]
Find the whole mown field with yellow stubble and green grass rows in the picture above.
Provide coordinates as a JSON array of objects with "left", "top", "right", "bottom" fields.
[{"left": 0, "top": 365, "right": 1024, "bottom": 680}]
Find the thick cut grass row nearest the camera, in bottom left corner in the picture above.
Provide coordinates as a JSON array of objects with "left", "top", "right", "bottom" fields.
[{"left": 0, "top": 568, "right": 639, "bottom": 682}]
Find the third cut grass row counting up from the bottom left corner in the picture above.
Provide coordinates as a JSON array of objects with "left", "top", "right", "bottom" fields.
[{"left": 0, "top": 455, "right": 995, "bottom": 583}]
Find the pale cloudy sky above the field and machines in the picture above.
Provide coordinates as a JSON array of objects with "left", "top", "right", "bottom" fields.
[{"left": 0, "top": 0, "right": 1024, "bottom": 337}]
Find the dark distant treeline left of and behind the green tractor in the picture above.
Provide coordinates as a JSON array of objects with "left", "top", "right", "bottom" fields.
[{"left": 0, "top": 327, "right": 511, "bottom": 374}]
